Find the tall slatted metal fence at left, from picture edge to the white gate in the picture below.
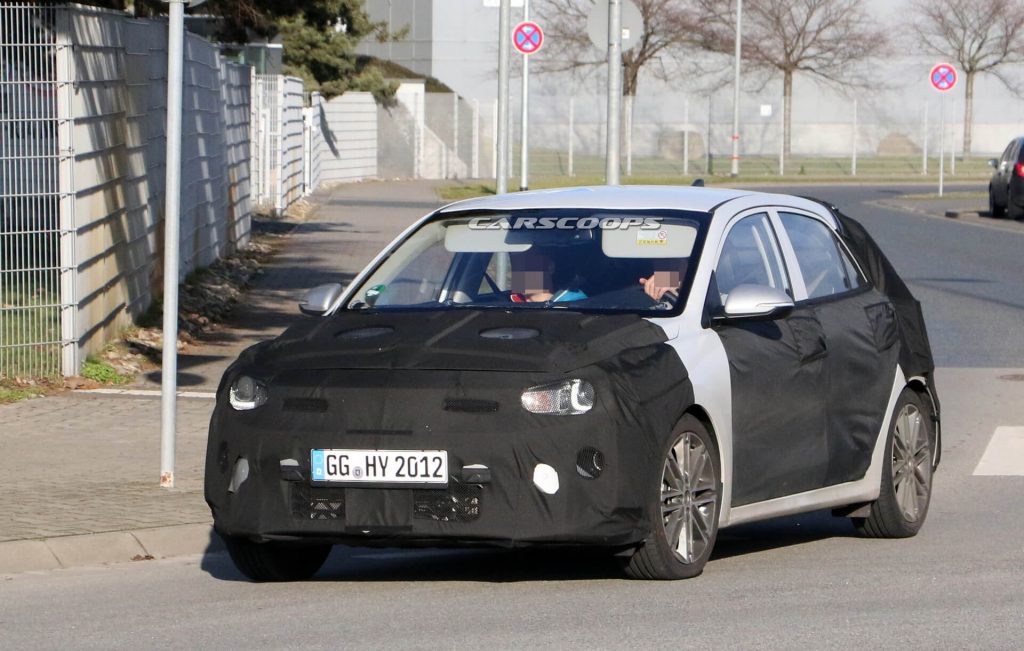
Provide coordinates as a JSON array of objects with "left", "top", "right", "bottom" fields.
[{"left": 0, "top": 2, "right": 250, "bottom": 378}]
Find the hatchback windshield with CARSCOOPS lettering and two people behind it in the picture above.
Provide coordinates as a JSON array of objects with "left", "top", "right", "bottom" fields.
[{"left": 346, "top": 210, "right": 709, "bottom": 315}]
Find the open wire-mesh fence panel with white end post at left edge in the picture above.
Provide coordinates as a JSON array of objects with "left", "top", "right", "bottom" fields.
[{"left": 0, "top": 3, "right": 75, "bottom": 377}]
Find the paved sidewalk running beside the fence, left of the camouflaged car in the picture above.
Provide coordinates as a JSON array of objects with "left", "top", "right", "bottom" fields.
[{"left": 0, "top": 182, "right": 439, "bottom": 574}]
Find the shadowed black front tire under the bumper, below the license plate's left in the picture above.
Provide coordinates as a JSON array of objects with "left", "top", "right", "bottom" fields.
[{"left": 224, "top": 537, "right": 331, "bottom": 582}]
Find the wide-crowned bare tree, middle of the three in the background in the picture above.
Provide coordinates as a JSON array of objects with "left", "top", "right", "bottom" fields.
[{"left": 694, "top": 0, "right": 888, "bottom": 156}]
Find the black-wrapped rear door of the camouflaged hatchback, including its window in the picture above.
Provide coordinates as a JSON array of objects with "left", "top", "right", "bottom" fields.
[{"left": 778, "top": 209, "right": 899, "bottom": 485}]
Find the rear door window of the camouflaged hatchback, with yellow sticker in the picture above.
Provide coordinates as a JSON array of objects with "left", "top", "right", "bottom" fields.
[{"left": 778, "top": 212, "right": 864, "bottom": 299}]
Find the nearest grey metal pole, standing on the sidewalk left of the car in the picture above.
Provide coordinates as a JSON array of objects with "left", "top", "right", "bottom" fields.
[{"left": 160, "top": 0, "right": 185, "bottom": 488}]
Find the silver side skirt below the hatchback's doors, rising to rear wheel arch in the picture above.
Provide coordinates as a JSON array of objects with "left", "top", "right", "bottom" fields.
[{"left": 719, "top": 366, "right": 906, "bottom": 529}]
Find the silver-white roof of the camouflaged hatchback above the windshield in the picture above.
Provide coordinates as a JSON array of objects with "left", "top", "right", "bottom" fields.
[{"left": 438, "top": 185, "right": 758, "bottom": 213}]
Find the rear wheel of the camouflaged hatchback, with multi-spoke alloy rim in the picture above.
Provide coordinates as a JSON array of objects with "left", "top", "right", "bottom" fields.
[{"left": 853, "top": 388, "right": 935, "bottom": 538}]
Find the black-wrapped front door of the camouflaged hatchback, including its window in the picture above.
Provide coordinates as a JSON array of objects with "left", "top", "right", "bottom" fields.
[{"left": 707, "top": 211, "right": 828, "bottom": 506}]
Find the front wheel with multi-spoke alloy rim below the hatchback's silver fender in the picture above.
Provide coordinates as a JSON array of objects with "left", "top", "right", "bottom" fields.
[{"left": 624, "top": 416, "right": 722, "bottom": 580}]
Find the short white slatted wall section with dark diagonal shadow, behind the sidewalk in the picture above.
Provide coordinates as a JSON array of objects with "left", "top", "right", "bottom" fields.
[{"left": 318, "top": 92, "right": 377, "bottom": 183}]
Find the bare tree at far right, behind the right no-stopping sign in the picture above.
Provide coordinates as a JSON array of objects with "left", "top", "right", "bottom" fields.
[{"left": 911, "top": 0, "right": 1024, "bottom": 156}]
